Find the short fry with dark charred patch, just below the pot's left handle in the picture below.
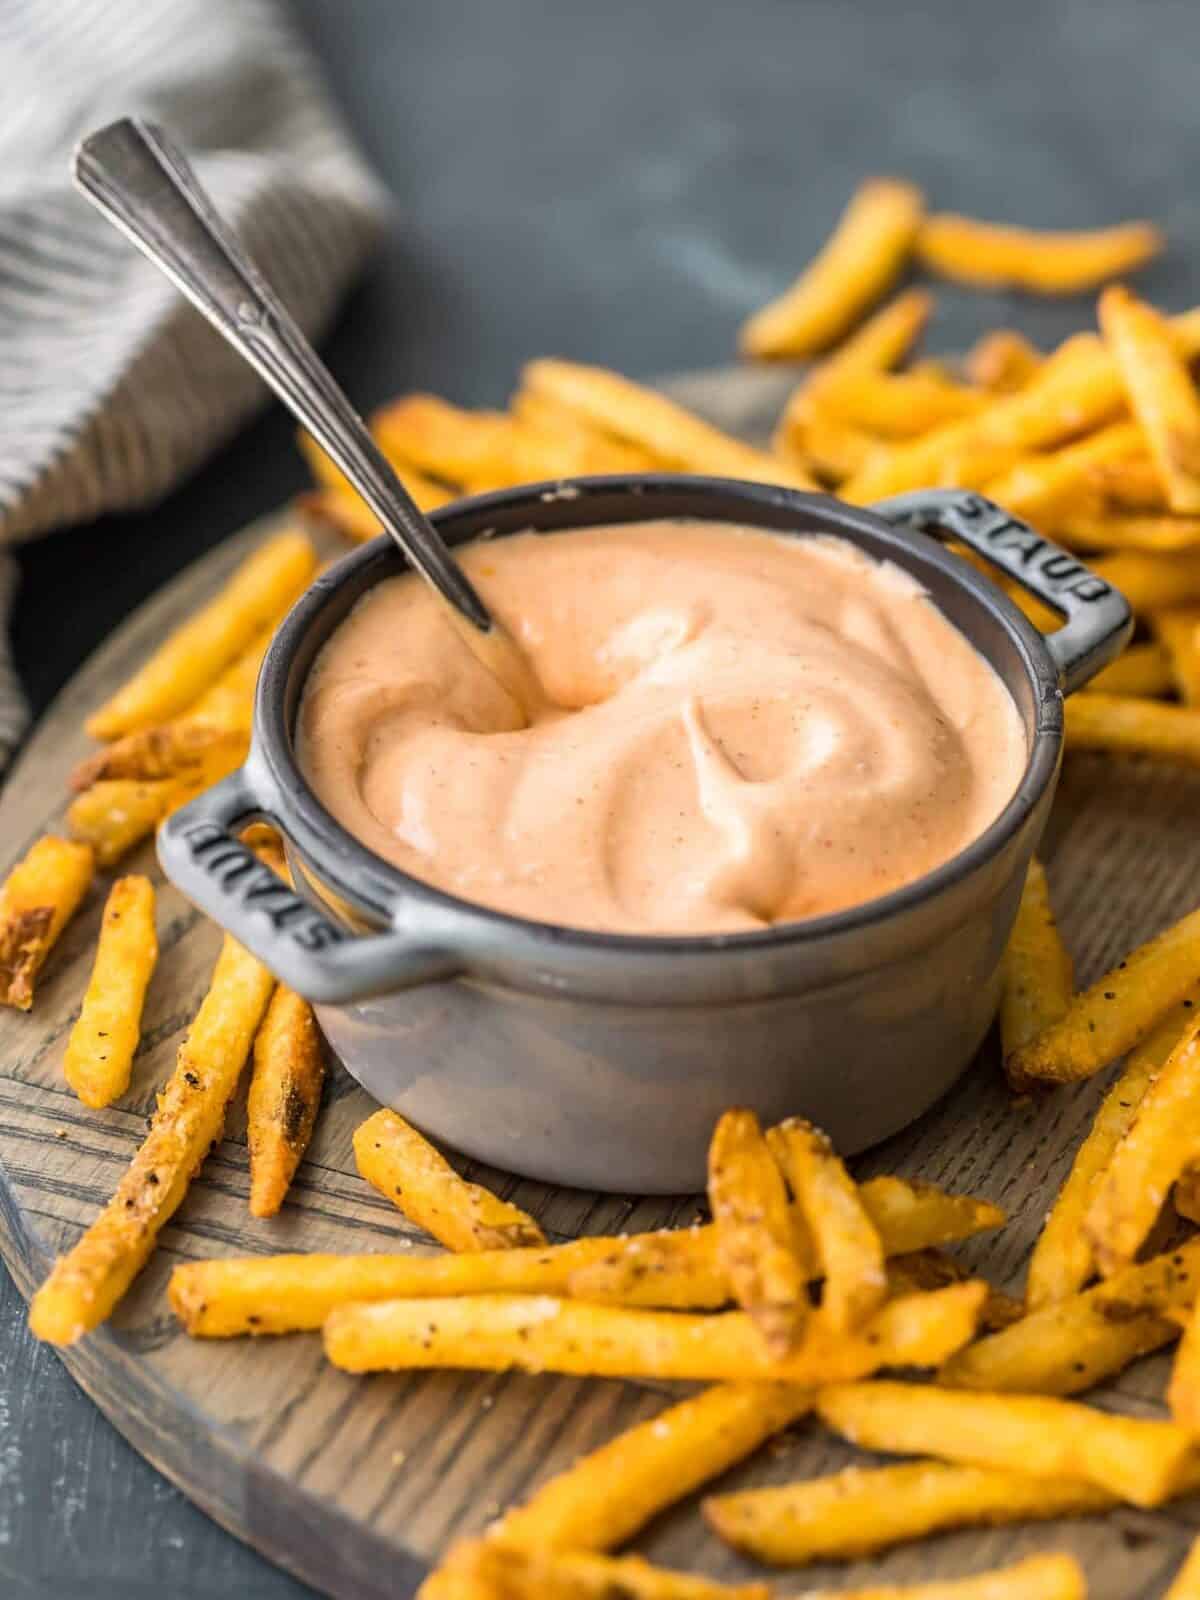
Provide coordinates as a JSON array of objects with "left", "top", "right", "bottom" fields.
[{"left": 246, "top": 984, "right": 325, "bottom": 1216}]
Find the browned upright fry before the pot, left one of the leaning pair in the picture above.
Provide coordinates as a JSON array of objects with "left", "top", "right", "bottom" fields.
[{"left": 709, "top": 1110, "right": 810, "bottom": 1358}]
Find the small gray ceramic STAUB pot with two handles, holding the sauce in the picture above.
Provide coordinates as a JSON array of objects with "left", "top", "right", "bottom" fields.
[{"left": 158, "top": 475, "right": 1131, "bottom": 1194}]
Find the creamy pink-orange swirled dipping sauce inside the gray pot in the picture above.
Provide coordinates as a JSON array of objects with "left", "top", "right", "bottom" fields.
[{"left": 299, "top": 522, "right": 1026, "bottom": 933}]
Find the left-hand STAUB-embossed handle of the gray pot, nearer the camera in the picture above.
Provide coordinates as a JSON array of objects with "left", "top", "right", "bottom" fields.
[{"left": 158, "top": 766, "right": 459, "bottom": 1005}]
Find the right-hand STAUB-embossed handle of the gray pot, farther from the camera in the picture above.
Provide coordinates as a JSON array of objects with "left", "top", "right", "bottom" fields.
[{"left": 870, "top": 490, "right": 1133, "bottom": 694}]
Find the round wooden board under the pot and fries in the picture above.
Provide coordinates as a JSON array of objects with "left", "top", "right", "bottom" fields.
[{"left": 0, "top": 373, "right": 1200, "bottom": 1600}]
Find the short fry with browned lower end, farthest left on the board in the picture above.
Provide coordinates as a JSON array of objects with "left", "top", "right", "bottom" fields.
[{"left": 0, "top": 835, "right": 93, "bottom": 1011}]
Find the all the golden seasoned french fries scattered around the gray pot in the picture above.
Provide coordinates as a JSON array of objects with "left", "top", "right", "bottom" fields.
[{"left": 11, "top": 179, "right": 1200, "bottom": 1600}]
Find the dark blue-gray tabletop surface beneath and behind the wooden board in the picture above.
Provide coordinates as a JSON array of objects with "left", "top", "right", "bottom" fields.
[{"left": 0, "top": 0, "right": 1200, "bottom": 1600}]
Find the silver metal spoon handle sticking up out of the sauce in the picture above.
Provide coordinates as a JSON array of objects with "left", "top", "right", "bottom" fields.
[{"left": 75, "top": 117, "right": 493, "bottom": 632}]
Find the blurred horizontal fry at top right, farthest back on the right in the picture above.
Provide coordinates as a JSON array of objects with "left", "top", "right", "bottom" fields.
[{"left": 917, "top": 213, "right": 1163, "bottom": 294}]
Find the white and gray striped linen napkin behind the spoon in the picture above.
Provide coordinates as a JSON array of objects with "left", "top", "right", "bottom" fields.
[{"left": 0, "top": 0, "right": 387, "bottom": 770}]
